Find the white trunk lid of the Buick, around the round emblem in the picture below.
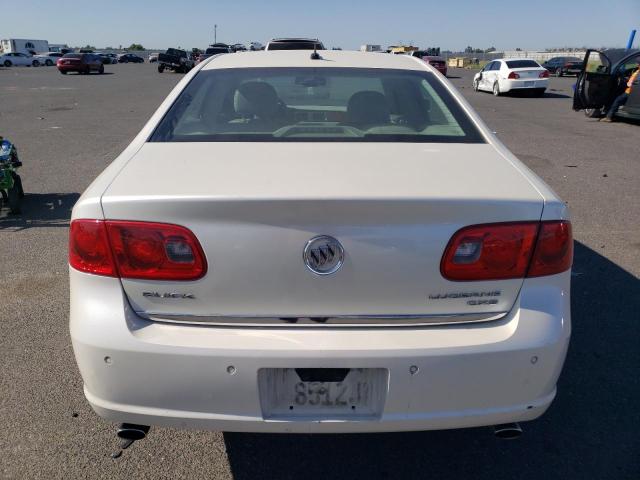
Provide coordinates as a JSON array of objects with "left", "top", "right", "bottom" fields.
[{"left": 102, "top": 143, "right": 543, "bottom": 318}]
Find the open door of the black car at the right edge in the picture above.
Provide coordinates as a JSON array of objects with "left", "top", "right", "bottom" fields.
[{"left": 573, "top": 50, "right": 615, "bottom": 110}]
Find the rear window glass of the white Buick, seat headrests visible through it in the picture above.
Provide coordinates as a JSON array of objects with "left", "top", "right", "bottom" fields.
[{"left": 150, "top": 67, "right": 484, "bottom": 143}]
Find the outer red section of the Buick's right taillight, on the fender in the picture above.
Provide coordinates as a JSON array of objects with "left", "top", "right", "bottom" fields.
[{"left": 527, "top": 220, "right": 573, "bottom": 277}]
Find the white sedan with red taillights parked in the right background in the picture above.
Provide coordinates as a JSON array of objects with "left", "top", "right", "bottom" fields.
[{"left": 473, "top": 58, "right": 549, "bottom": 97}]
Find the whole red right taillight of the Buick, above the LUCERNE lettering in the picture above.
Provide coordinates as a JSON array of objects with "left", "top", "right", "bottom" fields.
[{"left": 440, "top": 221, "right": 573, "bottom": 281}]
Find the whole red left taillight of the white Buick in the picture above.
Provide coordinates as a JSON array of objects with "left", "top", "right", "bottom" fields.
[{"left": 69, "top": 220, "right": 207, "bottom": 280}]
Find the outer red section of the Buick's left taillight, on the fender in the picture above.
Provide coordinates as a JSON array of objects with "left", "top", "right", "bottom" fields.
[{"left": 69, "top": 220, "right": 117, "bottom": 277}]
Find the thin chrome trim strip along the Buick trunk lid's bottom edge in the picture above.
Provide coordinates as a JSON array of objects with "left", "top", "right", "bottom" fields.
[{"left": 136, "top": 312, "right": 508, "bottom": 328}]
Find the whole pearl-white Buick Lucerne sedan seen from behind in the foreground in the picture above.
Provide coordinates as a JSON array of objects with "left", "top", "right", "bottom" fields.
[{"left": 69, "top": 50, "right": 572, "bottom": 438}]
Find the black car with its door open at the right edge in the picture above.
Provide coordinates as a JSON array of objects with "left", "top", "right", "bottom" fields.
[{"left": 573, "top": 48, "right": 640, "bottom": 120}]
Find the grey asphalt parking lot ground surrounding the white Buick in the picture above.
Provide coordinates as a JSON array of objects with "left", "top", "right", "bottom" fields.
[{"left": 0, "top": 64, "right": 640, "bottom": 480}]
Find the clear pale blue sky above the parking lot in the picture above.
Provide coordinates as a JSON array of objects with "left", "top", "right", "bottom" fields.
[{"left": 0, "top": 0, "right": 640, "bottom": 51}]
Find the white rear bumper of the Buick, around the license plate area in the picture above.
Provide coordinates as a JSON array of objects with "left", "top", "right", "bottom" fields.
[{"left": 70, "top": 270, "right": 570, "bottom": 433}]
